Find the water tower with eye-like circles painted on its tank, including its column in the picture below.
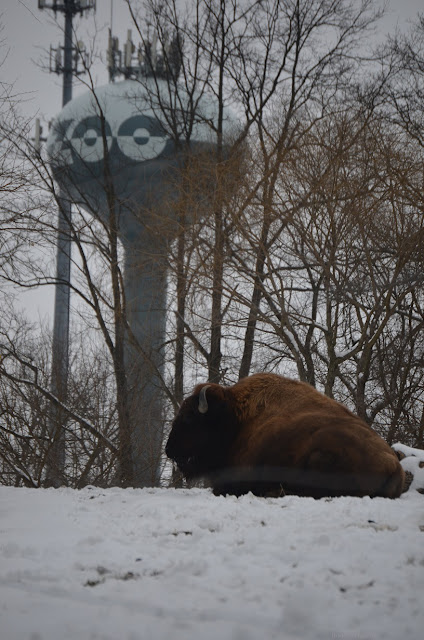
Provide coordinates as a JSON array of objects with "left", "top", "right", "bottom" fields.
[{"left": 47, "top": 79, "right": 222, "bottom": 486}]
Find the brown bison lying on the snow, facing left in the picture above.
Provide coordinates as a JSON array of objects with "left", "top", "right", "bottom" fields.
[{"left": 166, "top": 373, "right": 405, "bottom": 498}]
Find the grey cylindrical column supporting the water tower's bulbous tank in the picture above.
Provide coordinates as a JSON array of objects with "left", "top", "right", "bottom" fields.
[{"left": 125, "top": 239, "right": 166, "bottom": 487}]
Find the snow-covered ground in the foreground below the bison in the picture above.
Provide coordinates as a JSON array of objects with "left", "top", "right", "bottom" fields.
[{"left": 0, "top": 450, "right": 424, "bottom": 640}]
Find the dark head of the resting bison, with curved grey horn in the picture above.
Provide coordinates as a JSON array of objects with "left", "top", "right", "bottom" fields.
[{"left": 165, "top": 384, "right": 237, "bottom": 478}]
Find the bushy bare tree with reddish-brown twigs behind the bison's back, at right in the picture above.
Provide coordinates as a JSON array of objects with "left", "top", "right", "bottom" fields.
[{"left": 227, "top": 99, "right": 423, "bottom": 440}]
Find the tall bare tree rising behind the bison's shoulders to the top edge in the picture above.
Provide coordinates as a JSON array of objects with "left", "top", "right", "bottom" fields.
[{"left": 128, "top": 1, "right": 382, "bottom": 396}]
